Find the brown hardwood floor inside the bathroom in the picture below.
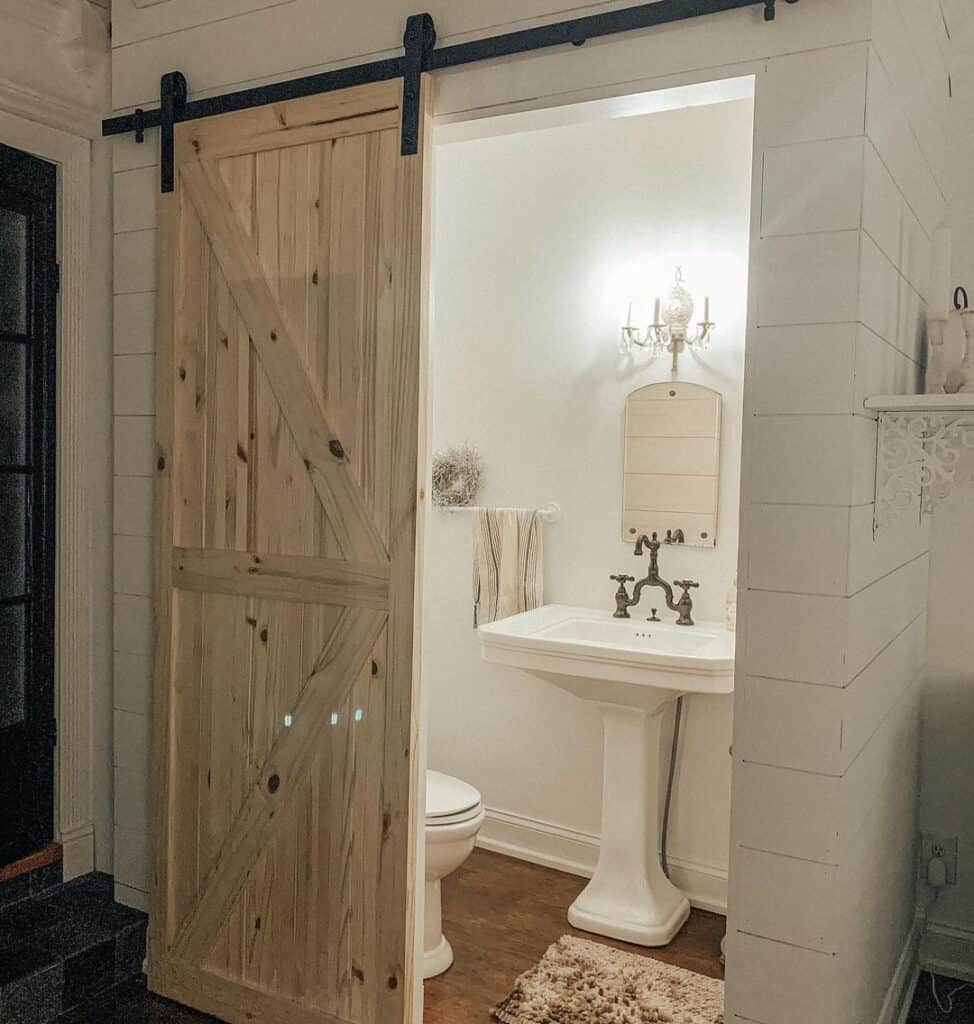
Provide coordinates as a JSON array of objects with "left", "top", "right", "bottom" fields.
[{"left": 423, "top": 850, "right": 725, "bottom": 1024}]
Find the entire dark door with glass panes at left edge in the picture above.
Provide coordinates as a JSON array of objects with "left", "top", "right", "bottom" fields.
[{"left": 0, "top": 145, "right": 57, "bottom": 865}]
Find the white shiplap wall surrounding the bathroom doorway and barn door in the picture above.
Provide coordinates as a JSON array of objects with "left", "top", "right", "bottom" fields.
[{"left": 108, "top": 0, "right": 944, "bottom": 1024}]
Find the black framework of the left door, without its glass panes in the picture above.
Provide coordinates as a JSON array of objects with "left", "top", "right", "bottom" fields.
[{"left": 0, "top": 144, "right": 58, "bottom": 864}]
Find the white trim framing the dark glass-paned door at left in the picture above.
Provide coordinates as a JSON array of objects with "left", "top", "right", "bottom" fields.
[{"left": 0, "top": 110, "right": 94, "bottom": 879}]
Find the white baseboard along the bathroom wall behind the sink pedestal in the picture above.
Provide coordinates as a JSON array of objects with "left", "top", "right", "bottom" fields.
[{"left": 477, "top": 807, "right": 727, "bottom": 914}]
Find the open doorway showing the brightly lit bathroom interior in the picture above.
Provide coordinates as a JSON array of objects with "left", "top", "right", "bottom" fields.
[{"left": 420, "top": 76, "right": 755, "bottom": 1024}]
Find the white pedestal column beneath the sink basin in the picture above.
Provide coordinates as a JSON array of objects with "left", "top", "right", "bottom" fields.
[{"left": 568, "top": 694, "right": 690, "bottom": 946}]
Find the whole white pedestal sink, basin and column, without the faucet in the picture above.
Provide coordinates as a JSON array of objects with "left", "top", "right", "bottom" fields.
[{"left": 478, "top": 604, "right": 734, "bottom": 946}]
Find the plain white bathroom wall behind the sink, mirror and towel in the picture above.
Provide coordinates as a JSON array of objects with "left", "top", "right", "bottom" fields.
[{"left": 423, "top": 99, "right": 753, "bottom": 905}]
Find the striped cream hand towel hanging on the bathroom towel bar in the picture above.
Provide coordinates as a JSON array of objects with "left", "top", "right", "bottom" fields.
[{"left": 473, "top": 509, "right": 545, "bottom": 627}]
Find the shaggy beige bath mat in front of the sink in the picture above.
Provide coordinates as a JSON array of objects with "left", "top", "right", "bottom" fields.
[{"left": 494, "top": 935, "right": 724, "bottom": 1024}]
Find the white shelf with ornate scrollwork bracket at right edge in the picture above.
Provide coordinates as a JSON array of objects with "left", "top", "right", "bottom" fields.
[{"left": 865, "top": 394, "right": 974, "bottom": 530}]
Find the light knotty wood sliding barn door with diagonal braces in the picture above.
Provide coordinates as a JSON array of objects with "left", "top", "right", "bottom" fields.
[{"left": 150, "top": 81, "right": 429, "bottom": 1024}]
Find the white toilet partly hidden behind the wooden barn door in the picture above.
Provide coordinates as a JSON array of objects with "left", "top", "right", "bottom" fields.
[{"left": 423, "top": 771, "right": 483, "bottom": 978}]
